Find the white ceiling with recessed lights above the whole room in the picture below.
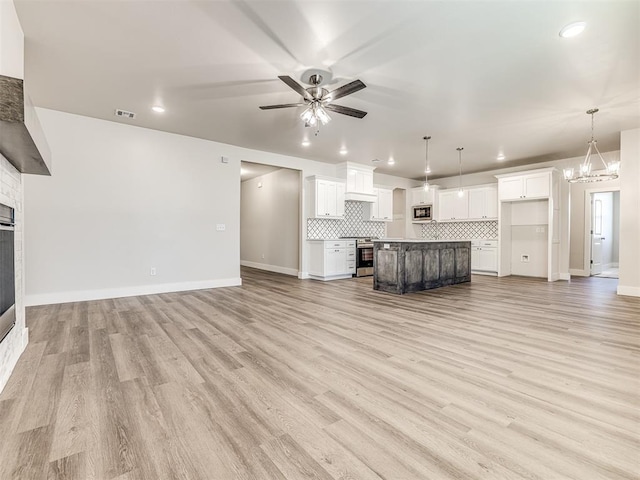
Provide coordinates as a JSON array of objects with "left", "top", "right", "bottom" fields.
[{"left": 16, "top": 0, "right": 640, "bottom": 178}]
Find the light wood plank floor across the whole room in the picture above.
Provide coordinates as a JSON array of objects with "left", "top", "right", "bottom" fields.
[{"left": 0, "top": 269, "right": 640, "bottom": 480}]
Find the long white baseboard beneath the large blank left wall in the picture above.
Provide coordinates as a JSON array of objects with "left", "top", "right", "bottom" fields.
[{"left": 24, "top": 278, "right": 242, "bottom": 307}]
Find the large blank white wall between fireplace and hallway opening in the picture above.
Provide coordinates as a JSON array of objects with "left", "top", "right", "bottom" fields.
[{"left": 24, "top": 110, "right": 240, "bottom": 305}]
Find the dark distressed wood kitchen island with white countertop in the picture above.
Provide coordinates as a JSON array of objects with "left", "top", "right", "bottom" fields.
[{"left": 373, "top": 240, "right": 471, "bottom": 294}]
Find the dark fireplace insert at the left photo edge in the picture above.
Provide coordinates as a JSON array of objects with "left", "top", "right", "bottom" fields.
[{"left": 0, "top": 204, "right": 16, "bottom": 342}]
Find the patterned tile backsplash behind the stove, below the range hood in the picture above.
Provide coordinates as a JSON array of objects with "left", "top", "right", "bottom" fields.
[{"left": 307, "top": 201, "right": 387, "bottom": 240}]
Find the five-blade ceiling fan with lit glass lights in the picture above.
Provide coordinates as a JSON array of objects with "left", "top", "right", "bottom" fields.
[{"left": 260, "top": 73, "right": 367, "bottom": 127}]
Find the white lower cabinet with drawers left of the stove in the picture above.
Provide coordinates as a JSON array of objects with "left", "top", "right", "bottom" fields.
[{"left": 309, "top": 240, "right": 356, "bottom": 280}]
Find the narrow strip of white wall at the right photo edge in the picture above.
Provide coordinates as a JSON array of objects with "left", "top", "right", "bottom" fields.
[{"left": 618, "top": 128, "right": 640, "bottom": 297}]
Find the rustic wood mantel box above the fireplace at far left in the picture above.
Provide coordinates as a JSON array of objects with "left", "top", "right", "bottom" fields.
[{"left": 0, "top": 75, "right": 51, "bottom": 175}]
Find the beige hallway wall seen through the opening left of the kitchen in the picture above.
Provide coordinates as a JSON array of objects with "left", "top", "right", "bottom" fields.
[{"left": 240, "top": 168, "right": 301, "bottom": 276}]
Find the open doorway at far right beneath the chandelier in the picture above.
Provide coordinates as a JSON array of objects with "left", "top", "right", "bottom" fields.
[{"left": 589, "top": 191, "right": 620, "bottom": 278}]
